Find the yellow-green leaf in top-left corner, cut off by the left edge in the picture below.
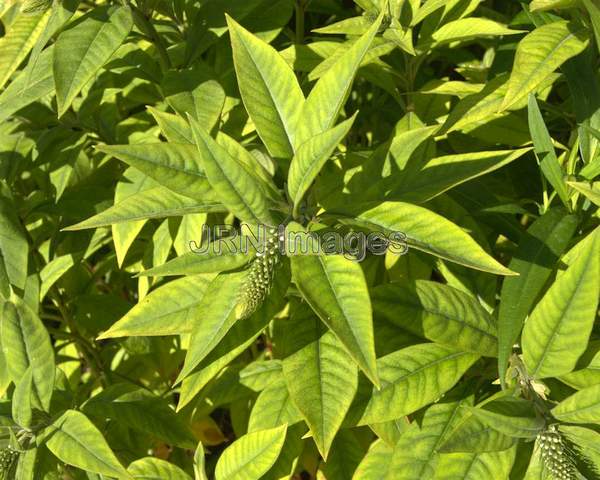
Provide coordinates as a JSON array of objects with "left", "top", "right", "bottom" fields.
[{"left": 0, "top": 11, "right": 50, "bottom": 89}]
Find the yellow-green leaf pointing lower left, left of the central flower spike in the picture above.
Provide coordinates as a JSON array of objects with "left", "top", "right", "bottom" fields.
[{"left": 99, "top": 275, "right": 218, "bottom": 339}]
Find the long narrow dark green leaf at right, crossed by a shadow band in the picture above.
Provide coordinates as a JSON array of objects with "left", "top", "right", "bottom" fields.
[{"left": 498, "top": 208, "right": 577, "bottom": 382}]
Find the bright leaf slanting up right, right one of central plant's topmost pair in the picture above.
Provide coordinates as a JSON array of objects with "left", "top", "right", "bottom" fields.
[{"left": 296, "top": 12, "right": 383, "bottom": 147}]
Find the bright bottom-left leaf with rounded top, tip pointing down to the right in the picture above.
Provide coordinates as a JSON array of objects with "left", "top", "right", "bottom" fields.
[{"left": 44, "top": 410, "right": 132, "bottom": 479}]
